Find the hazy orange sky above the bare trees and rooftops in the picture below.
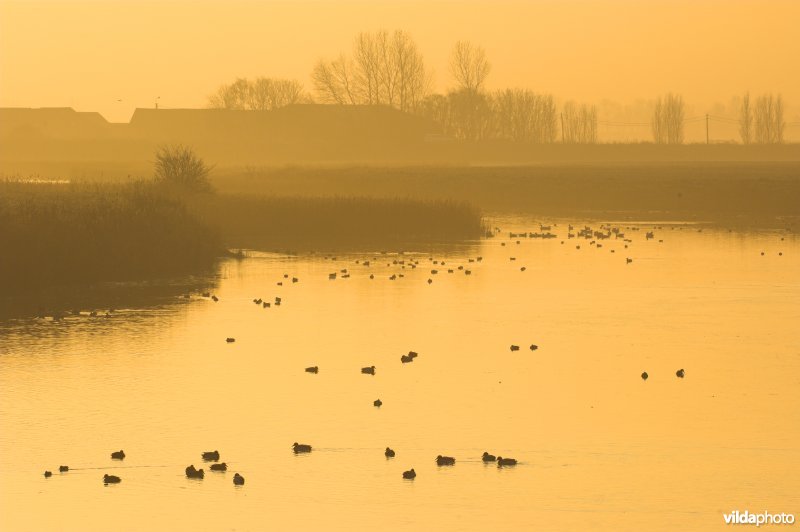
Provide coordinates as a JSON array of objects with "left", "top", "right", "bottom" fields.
[{"left": 0, "top": 0, "right": 800, "bottom": 121}]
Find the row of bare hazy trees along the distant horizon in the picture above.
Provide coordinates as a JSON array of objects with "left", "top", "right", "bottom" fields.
[{"left": 208, "top": 30, "right": 786, "bottom": 144}]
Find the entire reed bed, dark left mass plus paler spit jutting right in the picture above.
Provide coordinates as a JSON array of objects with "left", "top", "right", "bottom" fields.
[{"left": 0, "top": 181, "right": 483, "bottom": 291}]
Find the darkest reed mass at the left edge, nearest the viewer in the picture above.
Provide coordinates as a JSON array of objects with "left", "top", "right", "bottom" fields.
[{"left": 0, "top": 182, "right": 223, "bottom": 290}]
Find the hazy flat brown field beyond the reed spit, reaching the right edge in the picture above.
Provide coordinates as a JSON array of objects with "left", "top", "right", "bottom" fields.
[{"left": 214, "top": 162, "right": 800, "bottom": 225}]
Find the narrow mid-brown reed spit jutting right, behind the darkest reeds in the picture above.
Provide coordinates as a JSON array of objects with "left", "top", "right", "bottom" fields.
[{"left": 190, "top": 194, "right": 483, "bottom": 250}]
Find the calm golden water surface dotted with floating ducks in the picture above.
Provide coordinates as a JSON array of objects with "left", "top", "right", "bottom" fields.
[{"left": 0, "top": 219, "right": 800, "bottom": 530}]
